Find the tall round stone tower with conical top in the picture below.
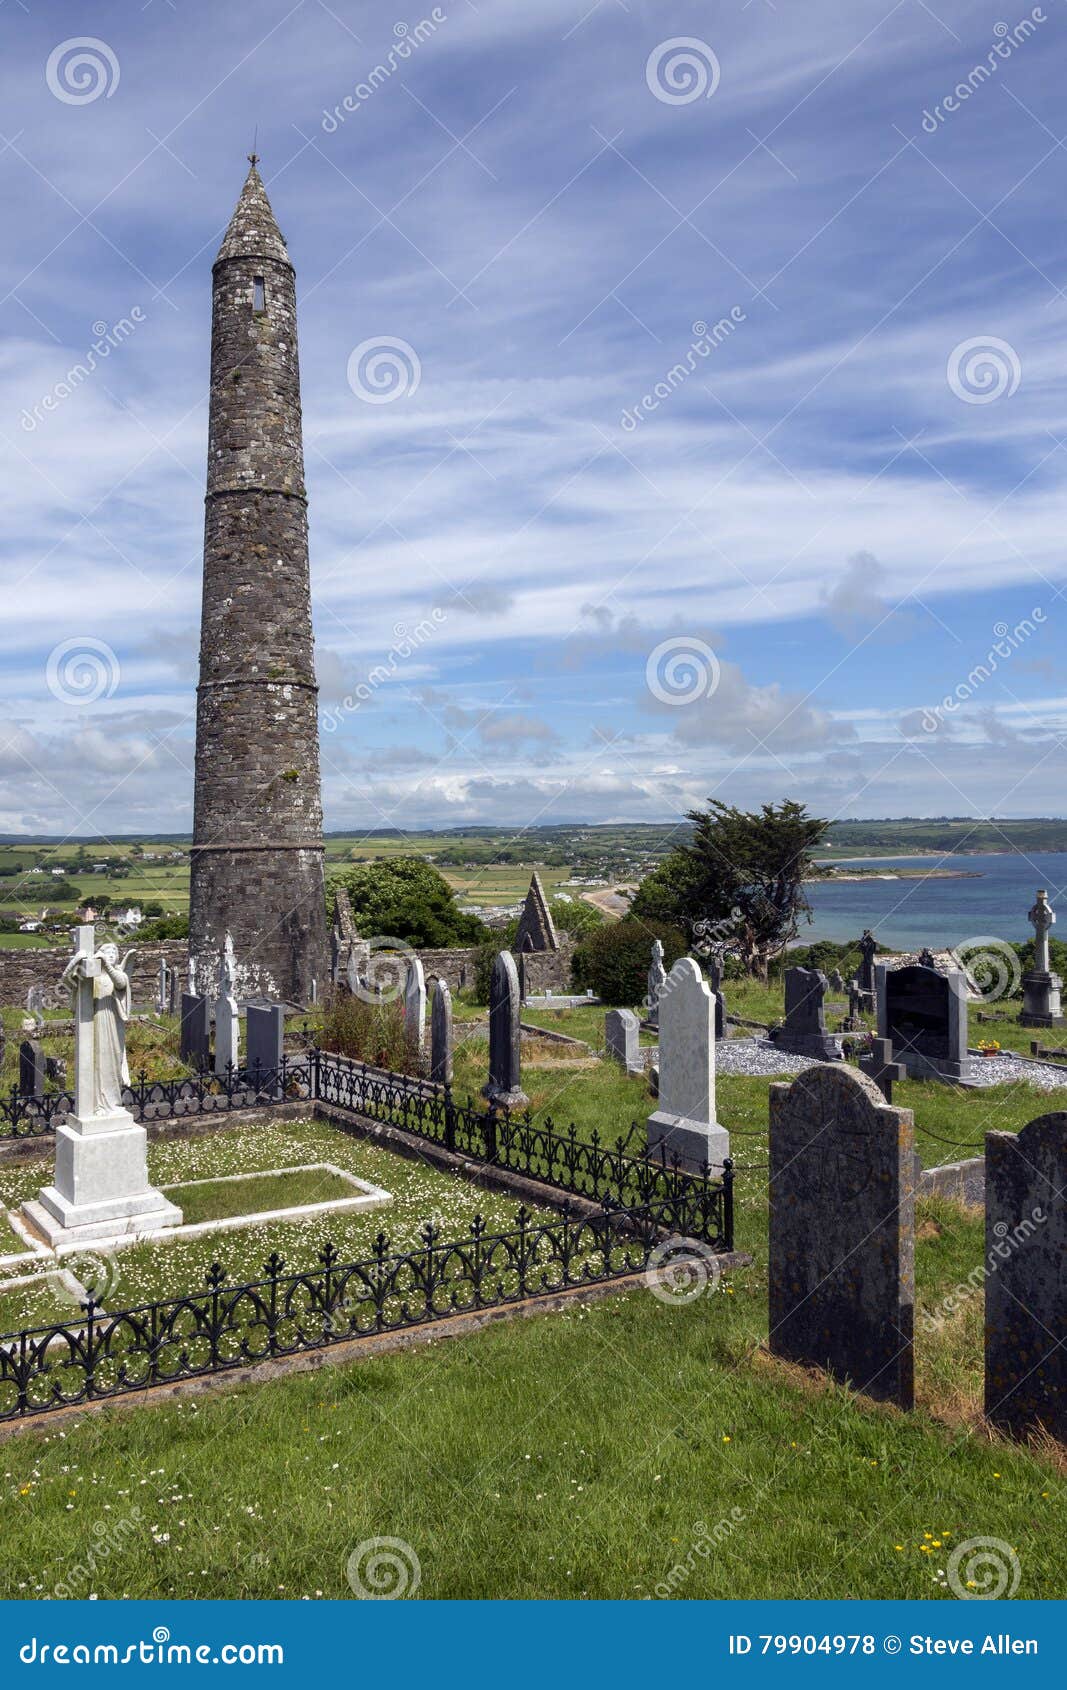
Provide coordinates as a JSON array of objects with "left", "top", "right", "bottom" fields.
[{"left": 189, "top": 157, "right": 326, "bottom": 1004}]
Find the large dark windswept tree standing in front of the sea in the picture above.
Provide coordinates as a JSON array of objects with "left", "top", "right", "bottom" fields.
[{"left": 632, "top": 799, "right": 829, "bottom": 980}]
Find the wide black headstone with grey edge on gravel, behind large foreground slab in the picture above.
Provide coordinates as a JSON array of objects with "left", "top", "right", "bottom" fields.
[{"left": 878, "top": 963, "right": 974, "bottom": 1082}]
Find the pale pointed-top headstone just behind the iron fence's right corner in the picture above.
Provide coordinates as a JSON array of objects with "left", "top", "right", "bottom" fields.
[{"left": 648, "top": 957, "right": 730, "bottom": 1171}]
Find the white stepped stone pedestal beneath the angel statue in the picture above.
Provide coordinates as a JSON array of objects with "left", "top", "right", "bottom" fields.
[{"left": 22, "top": 1109, "right": 181, "bottom": 1249}]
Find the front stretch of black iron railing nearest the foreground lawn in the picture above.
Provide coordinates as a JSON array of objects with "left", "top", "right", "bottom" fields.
[{"left": 0, "top": 1195, "right": 720, "bottom": 1421}]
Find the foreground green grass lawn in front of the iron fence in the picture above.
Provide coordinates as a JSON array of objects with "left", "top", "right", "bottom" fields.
[{"left": 0, "top": 1205, "right": 1067, "bottom": 1600}]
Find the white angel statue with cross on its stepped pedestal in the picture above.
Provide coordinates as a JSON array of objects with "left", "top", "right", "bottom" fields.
[{"left": 24, "top": 924, "right": 181, "bottom": 1249}]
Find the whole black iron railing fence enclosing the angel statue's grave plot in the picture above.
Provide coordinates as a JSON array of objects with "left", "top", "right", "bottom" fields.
[{"left": 0, "top": 1049, "right": 734, "bottom": 1421}]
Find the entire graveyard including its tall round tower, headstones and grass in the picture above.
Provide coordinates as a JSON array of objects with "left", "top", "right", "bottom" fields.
[{"left": 0, "top": 131, "right": 1067, "bottom": 1599}]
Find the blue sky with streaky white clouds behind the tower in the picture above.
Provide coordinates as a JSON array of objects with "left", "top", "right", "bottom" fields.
[{"left": 0, "top": 0, "right": 1067, "bottom": 835}]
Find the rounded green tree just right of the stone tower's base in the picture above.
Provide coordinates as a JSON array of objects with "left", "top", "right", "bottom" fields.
[{"left": 337, "top": 857, "right": 487, "bottom": 946}]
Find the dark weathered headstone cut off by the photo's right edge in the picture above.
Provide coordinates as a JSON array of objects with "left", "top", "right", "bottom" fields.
[{"left": 986, "top": 1114, "right": 1067, "bottom": 1442}]
